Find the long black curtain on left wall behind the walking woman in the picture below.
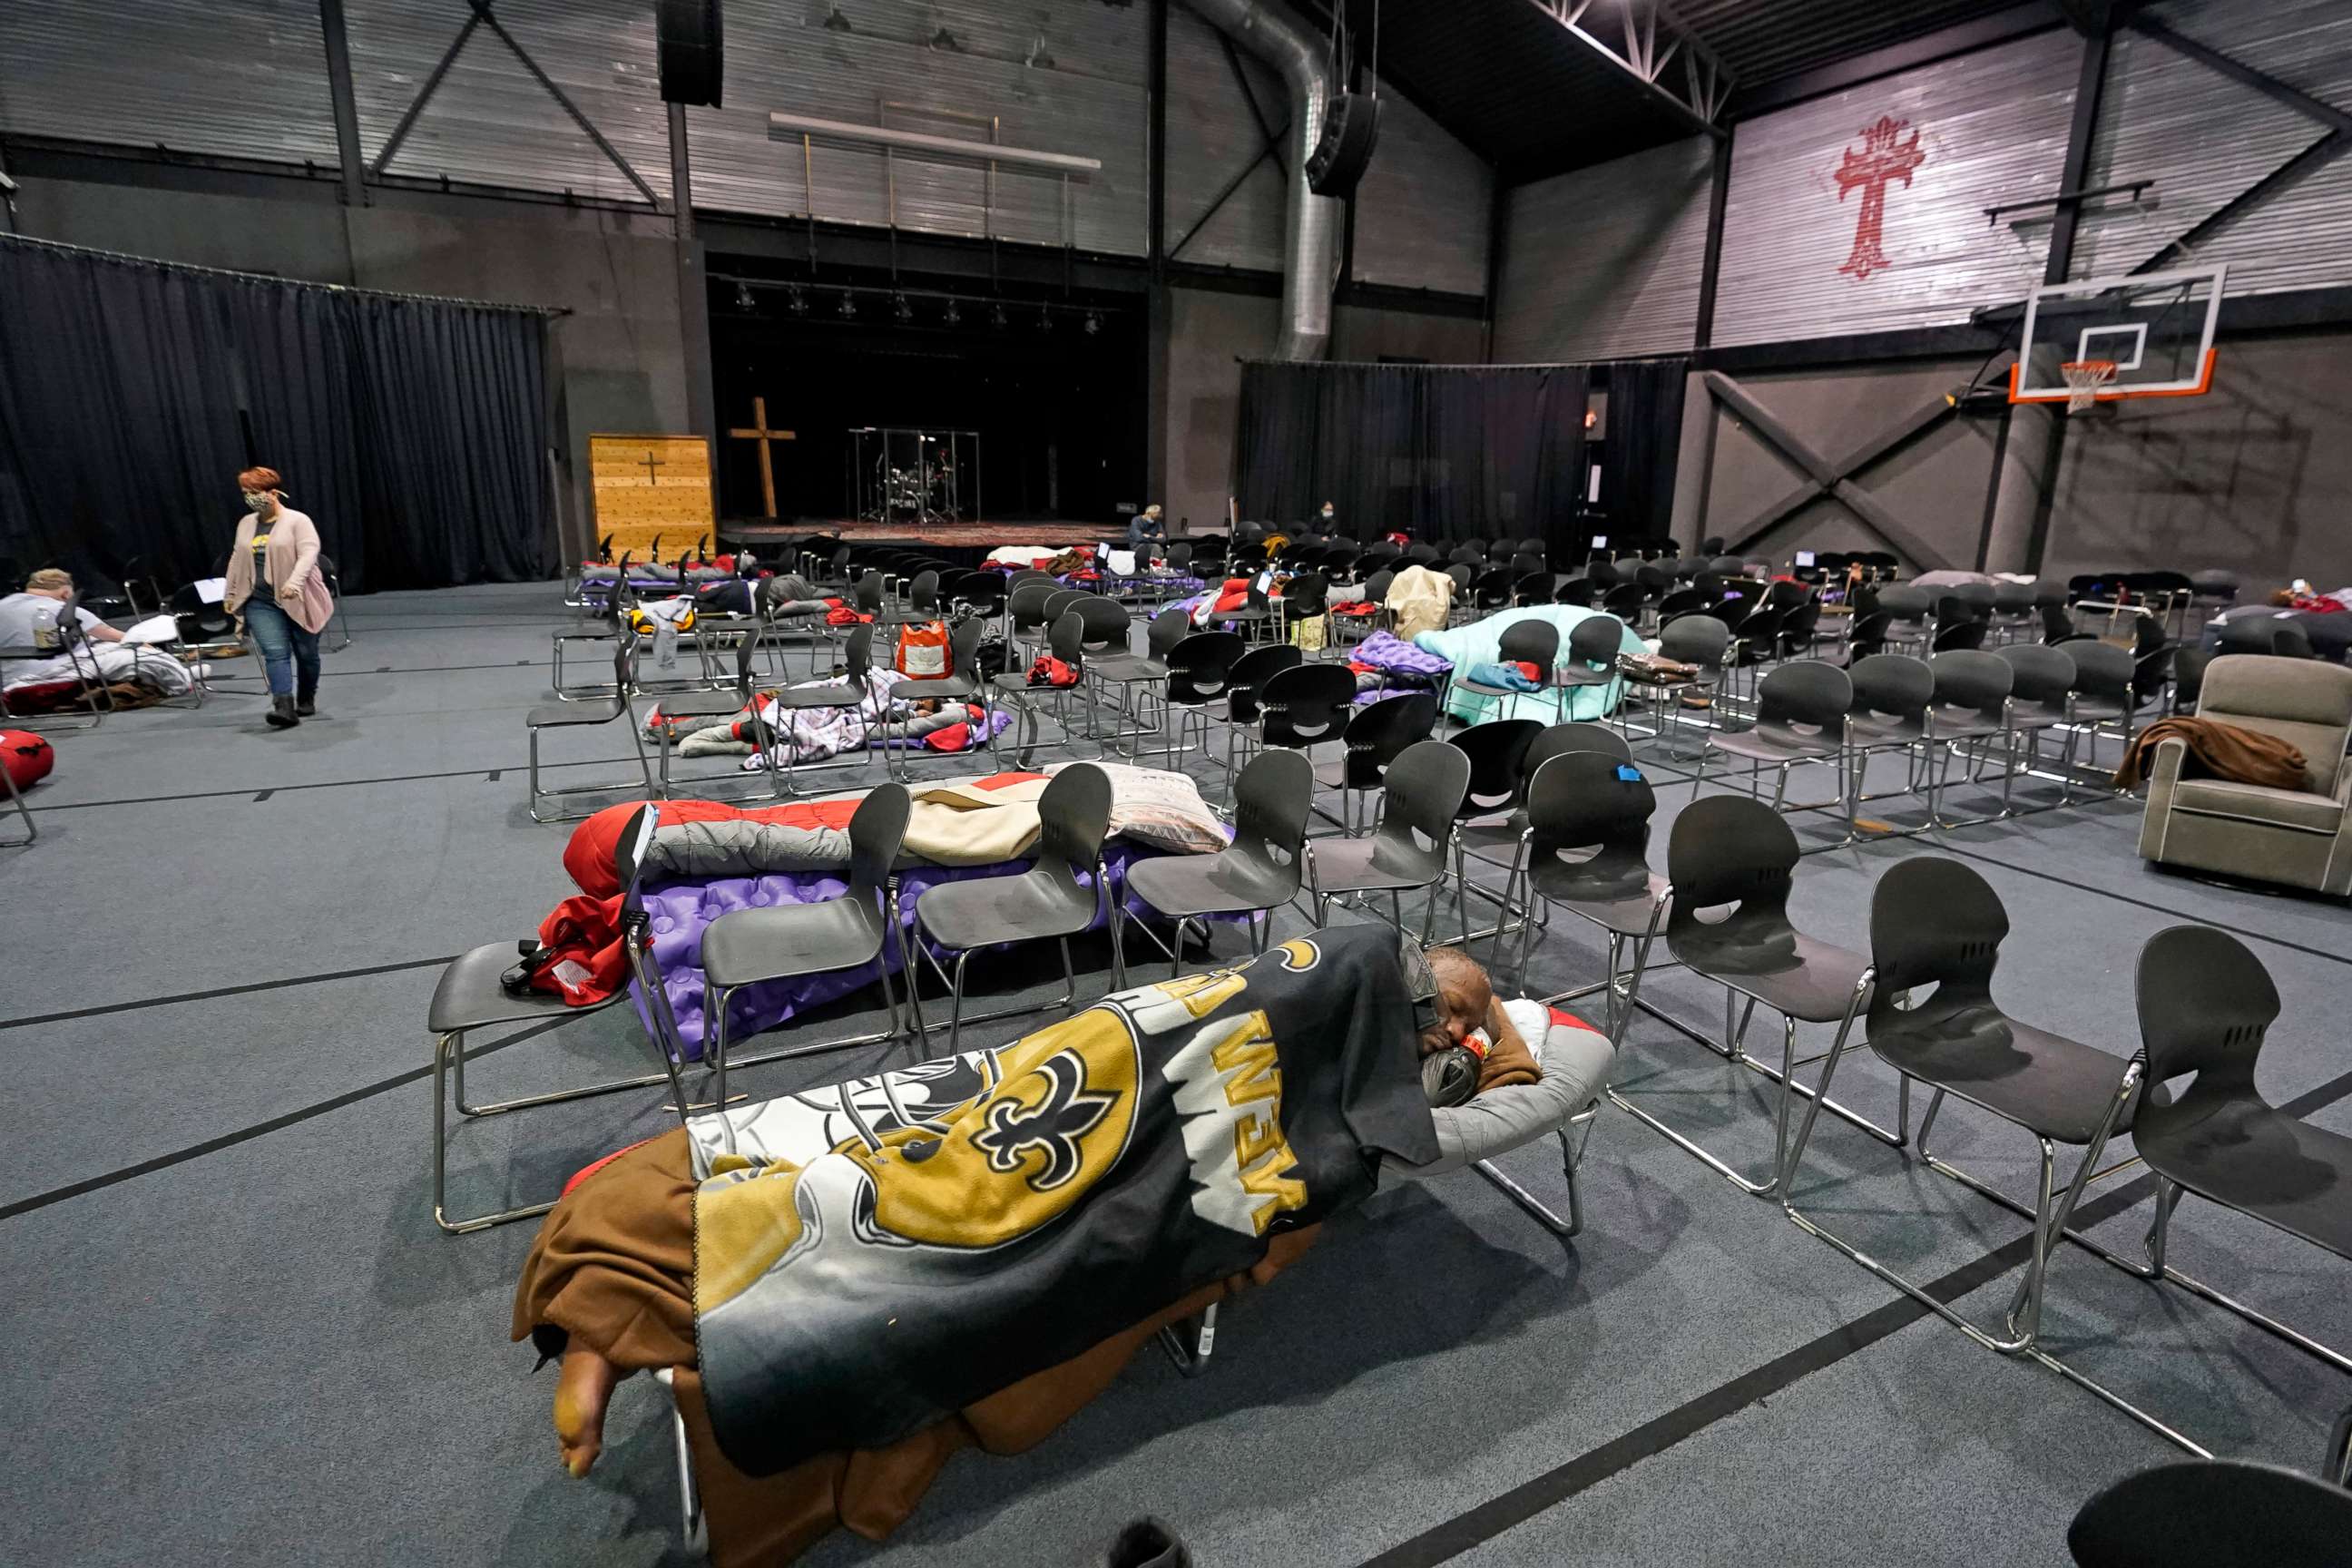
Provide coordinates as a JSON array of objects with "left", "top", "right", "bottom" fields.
[{"left": 0, "top": 235, "right": 555, "bottom": 593}]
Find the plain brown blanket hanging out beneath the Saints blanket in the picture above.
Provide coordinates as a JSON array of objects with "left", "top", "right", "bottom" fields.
[{"left": 513, "top": 1129, "right": 1319, "bottom": 1568}]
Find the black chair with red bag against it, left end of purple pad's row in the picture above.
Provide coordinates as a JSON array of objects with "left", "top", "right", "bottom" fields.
[{"left": 426, "top": 807, "right": 691, "bottom": 1237}]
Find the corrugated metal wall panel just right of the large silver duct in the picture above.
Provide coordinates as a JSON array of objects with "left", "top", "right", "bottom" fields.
[{"left": 1355, "top": 92, "right": 1494, "bottom": 294}]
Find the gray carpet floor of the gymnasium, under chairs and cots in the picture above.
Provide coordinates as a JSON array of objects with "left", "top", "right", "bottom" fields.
[{"left": 0, "top": 585, "right": 2352, "bottom": 1568}]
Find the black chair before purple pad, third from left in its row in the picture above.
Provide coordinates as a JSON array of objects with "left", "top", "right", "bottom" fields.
[{"left": 908, "top": 761, "right": 1127, "bottom": 1055}]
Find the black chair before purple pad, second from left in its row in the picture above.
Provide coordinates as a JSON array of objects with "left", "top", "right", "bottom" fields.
[{"left": 703, "top": 783, "right": 925, "bottom": 1113}]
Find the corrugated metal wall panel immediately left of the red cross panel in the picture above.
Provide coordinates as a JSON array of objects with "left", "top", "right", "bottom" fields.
[{"left": 1494, "top": 136, "right": 1715, "bottom": 362}]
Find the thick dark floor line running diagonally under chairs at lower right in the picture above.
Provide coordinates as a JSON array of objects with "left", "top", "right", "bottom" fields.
[{"left": 1362, "top": 1053, "right": 2352, "bottom": 1568}]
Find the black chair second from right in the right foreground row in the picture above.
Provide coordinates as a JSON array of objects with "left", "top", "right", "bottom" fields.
[{"left": 1783, "top": 856, "right": 2141, "bottom": 1361}]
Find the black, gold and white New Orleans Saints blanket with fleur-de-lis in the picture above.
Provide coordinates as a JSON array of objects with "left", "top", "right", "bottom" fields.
[{"left": 691, "top": 926, "right": 1437, "bottom": 1474}]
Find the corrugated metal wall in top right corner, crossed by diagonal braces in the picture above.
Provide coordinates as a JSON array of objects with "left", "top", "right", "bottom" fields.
[{"left": 2074, "top": 0, "right": 2352, "bottom": 294}]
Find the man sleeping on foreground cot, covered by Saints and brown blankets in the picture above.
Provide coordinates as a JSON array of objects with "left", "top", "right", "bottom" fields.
[{"left": 513, "top": 926, "right": 1606, "bottom": 1565}]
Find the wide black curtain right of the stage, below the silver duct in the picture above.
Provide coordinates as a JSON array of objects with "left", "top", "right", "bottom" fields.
[{"left": 1232, "top": 362, "right": 1588, "bottom": 560}]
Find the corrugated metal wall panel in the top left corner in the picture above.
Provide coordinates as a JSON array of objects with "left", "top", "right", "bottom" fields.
[{"left": 0, "top": 0, "right": 337, "bottom": 164}]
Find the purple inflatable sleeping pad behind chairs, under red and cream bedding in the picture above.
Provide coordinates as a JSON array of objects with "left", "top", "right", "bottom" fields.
[{"left": 631, "top": 839, "right": 1213, "bottom": 1060}]
